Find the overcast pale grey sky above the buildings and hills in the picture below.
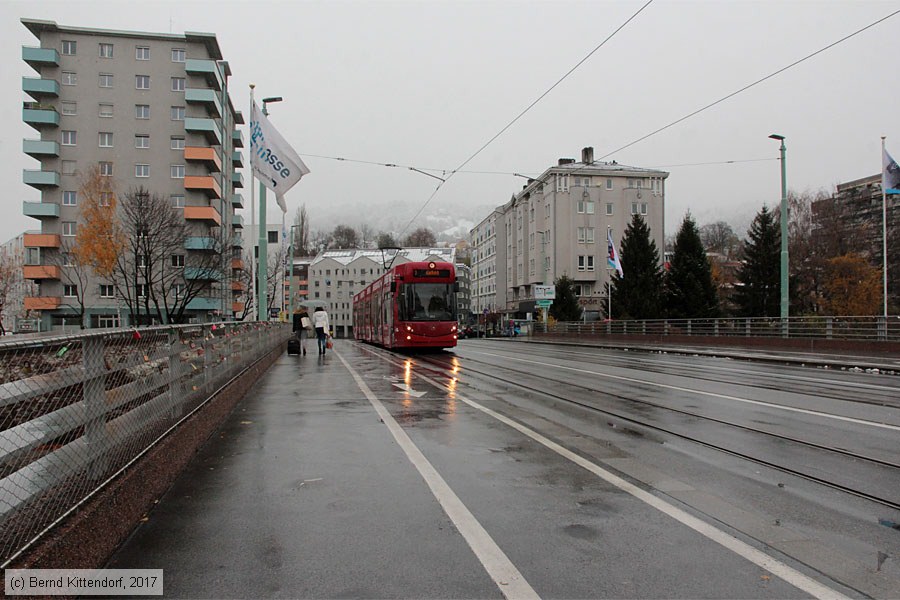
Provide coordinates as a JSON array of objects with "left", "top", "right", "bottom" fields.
[{"left": 0, "top": 0, "right": 900, "bottom": 241}]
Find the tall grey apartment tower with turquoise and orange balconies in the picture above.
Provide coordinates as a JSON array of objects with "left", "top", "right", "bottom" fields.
[{"left": 22, "top": 19, "right": 244, "bottom": 330}]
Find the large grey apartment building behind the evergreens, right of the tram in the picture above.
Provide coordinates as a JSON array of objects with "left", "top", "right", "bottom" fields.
[{"left": 471, "top": 147, "right": 669, "bottom": 318}]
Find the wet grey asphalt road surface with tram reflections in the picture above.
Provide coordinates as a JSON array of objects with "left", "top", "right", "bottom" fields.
[{"left": 109, "top": 340, "right": 900, "bottom": 598}]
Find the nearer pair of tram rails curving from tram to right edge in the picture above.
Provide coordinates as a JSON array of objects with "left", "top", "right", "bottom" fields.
[{"left": 417, "top": 356, "right": 900, "bottom": 510}]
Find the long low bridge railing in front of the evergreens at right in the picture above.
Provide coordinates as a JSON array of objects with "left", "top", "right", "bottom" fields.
[{"left": 535, "top": 316, "right": 900, "bottom": 342}]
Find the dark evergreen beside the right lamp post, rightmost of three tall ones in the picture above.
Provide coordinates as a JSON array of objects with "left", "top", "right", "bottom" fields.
[{"left": 734, "top": 206, "right": 781, "bottom": 317}]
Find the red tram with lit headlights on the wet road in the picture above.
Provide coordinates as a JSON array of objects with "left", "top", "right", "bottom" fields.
[{"left": 353, "top": 262, "right": 459, "bottom": 349}]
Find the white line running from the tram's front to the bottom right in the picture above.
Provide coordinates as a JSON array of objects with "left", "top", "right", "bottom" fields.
[{"left": 402, "top": 364, "right": 849, "bottom": 600}]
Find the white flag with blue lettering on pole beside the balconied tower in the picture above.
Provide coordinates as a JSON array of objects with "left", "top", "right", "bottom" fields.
[{"left": 250, "top": 102, "right": 309, "bottom": 212}]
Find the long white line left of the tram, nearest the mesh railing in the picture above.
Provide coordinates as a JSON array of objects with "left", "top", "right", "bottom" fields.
[{"left": 334, "top": 352, "right": 540, "bottom": 600}]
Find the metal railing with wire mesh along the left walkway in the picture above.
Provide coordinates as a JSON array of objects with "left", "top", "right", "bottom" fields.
[{"left": 0, "top": 322, "right": 290, "bottom": 563}]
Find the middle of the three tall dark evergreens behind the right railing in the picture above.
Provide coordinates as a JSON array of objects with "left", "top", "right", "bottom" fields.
[{"left": 666, "top": 213, "right": 719, "bottom": 319}]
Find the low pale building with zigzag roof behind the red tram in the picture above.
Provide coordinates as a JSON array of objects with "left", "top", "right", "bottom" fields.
[{"left": 308, "top": 248, "right": 456, "bottom": 337}]
